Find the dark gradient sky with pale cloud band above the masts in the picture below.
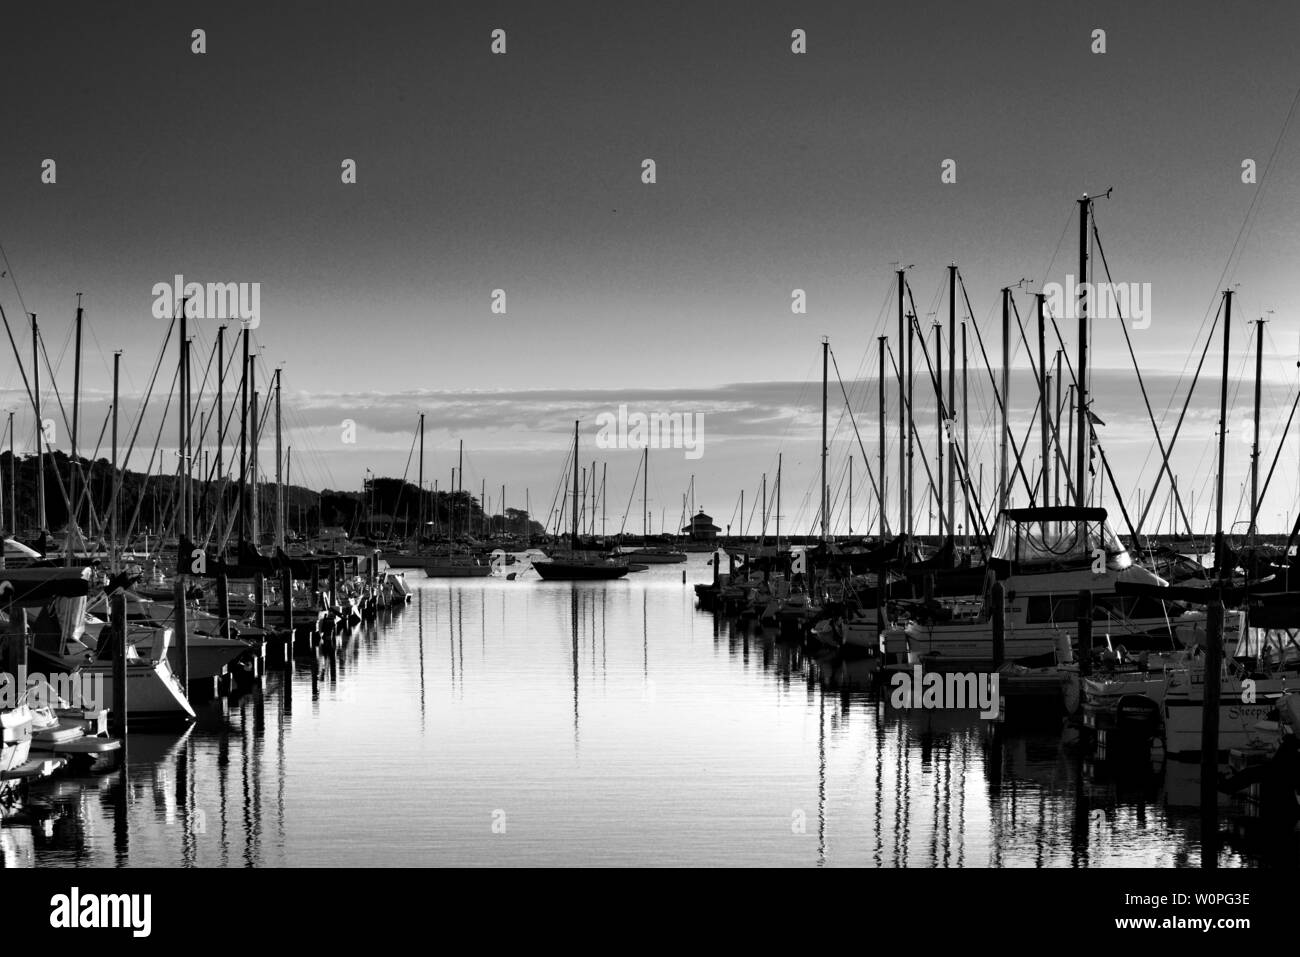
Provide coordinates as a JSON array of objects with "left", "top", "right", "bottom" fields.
[{"left": 0, "top": 0, "right": 1300, "bottom": 532}]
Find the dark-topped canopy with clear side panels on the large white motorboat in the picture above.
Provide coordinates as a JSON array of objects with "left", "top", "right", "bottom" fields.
[{"left": 993, "top": 506, "right": 1131, "bottom": 568}]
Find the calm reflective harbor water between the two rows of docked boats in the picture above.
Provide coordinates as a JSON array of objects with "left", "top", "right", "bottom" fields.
[{"left": 0, "top": 555, "right": 1244, "bottom": 867}]
